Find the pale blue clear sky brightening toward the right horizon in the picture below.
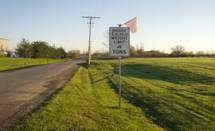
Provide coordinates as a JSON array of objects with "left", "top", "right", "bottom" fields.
[{"left": 0, "top": 0, "right": 215, "bottom": 52}]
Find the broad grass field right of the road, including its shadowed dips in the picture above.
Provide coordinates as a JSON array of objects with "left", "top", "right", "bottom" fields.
[{"left": 15, "top": 58, "right": 215, "bottom": 131}]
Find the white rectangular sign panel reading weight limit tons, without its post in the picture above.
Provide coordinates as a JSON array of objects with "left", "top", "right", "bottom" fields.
[{"left": 109, "top": 27, "right": 130, "bottom": 56}]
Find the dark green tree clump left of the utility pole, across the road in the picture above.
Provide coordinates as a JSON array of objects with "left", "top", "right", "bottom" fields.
[{"left": 4, "top": 38, "right": 81, "bottom": 59}]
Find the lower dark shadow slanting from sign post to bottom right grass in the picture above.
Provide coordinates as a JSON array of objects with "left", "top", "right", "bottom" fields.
[{"left": 108, "top": 78, "right": 198, "bottom": 130}]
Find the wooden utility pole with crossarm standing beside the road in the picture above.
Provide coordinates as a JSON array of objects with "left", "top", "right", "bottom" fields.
[{"left": 82, "top": 16, "right": 100, "bottom": 65}]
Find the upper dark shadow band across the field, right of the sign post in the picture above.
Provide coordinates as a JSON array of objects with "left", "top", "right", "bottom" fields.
[{"left": 117, "top": 64, "right": 215, "bottom": 85}]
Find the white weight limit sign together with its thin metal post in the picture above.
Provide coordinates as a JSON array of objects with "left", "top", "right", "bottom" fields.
[{"left": 109, "top": 25, "right": 130, "bottom": 108}]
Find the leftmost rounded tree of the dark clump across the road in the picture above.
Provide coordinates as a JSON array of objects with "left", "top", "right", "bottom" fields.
[{"left": 16, "top": 38, "right": 33, "bottom": 58}]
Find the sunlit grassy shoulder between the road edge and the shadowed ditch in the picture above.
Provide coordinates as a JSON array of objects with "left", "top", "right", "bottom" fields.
[{"left": 16, "top": 68, "right": 162, "bottom": 130}]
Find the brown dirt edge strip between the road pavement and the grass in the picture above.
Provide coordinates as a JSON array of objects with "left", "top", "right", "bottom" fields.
[{"left": 0, "top": 64, "right": 80, "bottom": 131}]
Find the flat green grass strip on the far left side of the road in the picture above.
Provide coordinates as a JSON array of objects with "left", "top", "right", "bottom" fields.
[{"left": 0, "top": 58, "right": 62, "bottom": 71}]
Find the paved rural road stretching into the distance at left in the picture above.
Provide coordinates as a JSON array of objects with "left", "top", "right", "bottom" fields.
[{"left": 0, "top": 61, "right": 83, "bottom": 130}]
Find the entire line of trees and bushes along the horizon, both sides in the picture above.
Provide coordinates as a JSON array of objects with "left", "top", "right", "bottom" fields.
[{"left": 3, "top": 38, "right": 215, "bottom": 59}]
